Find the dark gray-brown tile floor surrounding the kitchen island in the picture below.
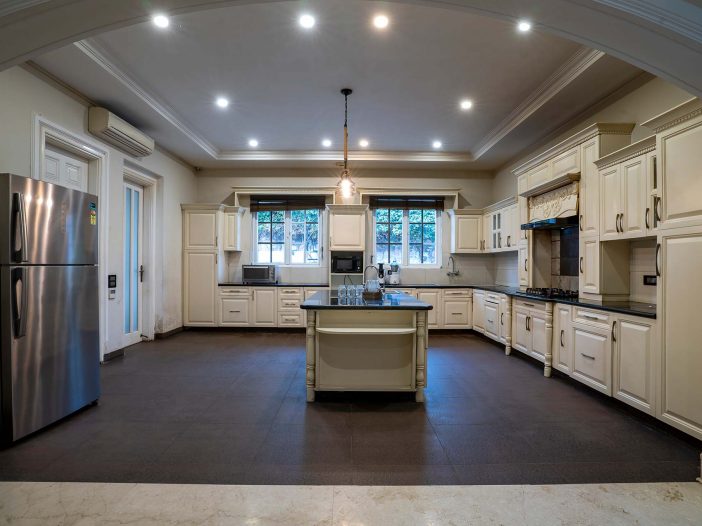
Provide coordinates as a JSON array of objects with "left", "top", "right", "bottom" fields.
[{"left": 0, "top": 331, "right": 702, "bottom": 484}]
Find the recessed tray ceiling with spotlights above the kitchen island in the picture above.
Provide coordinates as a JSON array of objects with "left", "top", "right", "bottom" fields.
[{"left": 34, "top": 0, "right": 641, "bottom": 169}]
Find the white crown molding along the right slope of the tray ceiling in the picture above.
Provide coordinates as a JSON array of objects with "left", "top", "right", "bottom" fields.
[{"left": 473, "top": 46, "right": 605, "bottom": 160}]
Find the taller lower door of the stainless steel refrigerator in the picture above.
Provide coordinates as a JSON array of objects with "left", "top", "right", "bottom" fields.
[{"left": 0, "top": 266, "right": 100, "bottom": 440}]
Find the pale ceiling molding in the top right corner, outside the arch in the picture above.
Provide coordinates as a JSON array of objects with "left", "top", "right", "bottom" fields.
[{"left": 595, "top": 0, "right": 702, "bottom": 44}]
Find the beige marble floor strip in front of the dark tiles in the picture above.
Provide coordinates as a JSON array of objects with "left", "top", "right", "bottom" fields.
[{"left": 0, "top": 482, "right": 702, "bottom": 526}]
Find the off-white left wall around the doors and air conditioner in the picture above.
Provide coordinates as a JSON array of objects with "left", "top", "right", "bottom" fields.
[{"left": 0, "top": 67, "right": 196, "bottom": 352}]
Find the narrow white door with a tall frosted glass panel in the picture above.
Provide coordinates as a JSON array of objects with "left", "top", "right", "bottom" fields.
[{"left": 122, "top": 182, "right": 144, "bottom": 346}]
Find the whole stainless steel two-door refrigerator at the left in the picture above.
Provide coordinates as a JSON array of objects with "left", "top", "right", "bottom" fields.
[{"left": 0, "top": 174, "right": 100, "bottom": 442}]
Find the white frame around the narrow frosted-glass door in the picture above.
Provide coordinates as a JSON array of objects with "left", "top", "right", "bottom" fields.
[{"left": 122, "top": 167, "right": 158, "bottom": 340}]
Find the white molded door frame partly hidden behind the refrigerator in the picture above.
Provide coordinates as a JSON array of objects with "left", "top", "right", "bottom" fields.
[{"left": 30, "top": 113, "right": 110, "bottom": 361}]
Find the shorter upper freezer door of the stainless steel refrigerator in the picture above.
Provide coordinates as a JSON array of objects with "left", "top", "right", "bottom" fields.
[{"left": 0, "top": 174, "right": 98, "bottom": 265}]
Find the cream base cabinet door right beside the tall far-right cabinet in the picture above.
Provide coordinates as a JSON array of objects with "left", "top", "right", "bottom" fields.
[{"left": 612, "top": 316, "right": 655, "bottom": 414}]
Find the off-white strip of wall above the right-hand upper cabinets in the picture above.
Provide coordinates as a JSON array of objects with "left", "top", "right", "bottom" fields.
[{"left": 492, "top": 78, "right": 692, "bottom": 201}]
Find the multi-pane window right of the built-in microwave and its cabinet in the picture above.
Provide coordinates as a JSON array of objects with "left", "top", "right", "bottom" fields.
[{"left": 373, "top": 208, "right": 441, "bottom": 267}]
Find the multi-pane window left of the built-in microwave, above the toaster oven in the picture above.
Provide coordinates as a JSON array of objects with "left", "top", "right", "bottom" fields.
[{"left": 253, "top": 209, "right": 322, "bottom": 266}]
